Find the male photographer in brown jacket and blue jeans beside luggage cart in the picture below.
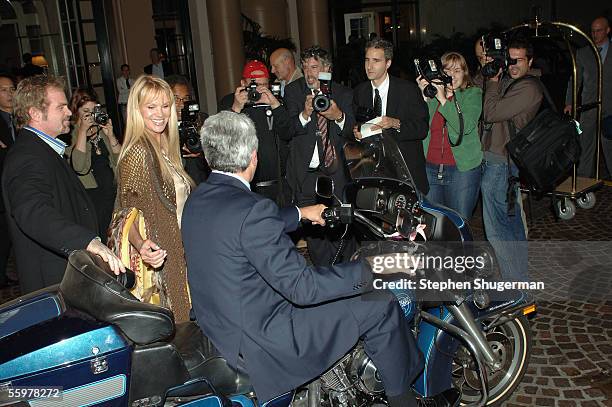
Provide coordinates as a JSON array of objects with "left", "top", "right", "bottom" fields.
[{"left": 481, "top": 39, "right": 543, "bottom": 280}]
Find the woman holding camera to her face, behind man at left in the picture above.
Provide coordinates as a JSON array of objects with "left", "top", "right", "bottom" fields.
[{"left": 66, "top": 88, "right": 121, "bottom": 242}]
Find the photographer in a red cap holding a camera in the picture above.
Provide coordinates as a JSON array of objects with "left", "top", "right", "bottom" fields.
[{"left": 219, "top": 60, "right": 290, "bottom": 207}]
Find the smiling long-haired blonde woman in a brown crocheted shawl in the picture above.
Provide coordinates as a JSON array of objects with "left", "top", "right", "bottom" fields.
[{"left": 117, "top": 76, "right": 193, "bottom": 321}]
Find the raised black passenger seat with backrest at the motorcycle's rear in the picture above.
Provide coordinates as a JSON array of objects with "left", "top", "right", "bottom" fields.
[{"left": 59, "top": 250, "right": 175, "bottom": 345}]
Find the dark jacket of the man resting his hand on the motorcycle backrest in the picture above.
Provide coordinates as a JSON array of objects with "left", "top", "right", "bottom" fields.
[{"left": 2, "top": 129, "right": 98, "bottom": 294}]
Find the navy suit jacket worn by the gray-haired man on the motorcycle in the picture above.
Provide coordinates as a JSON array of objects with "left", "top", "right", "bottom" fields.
[{"left": 182, "top": 172, "right": 372, "bottom": 401}]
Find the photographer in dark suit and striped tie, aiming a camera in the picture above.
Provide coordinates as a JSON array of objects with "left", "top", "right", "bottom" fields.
[{"left": 285, "top": 46, "right": 355, "bottom": 265}]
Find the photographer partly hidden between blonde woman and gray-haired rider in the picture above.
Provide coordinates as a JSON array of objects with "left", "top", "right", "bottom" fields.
[{"left": 165, "top": 75, "right": 210, "bottom": 185}]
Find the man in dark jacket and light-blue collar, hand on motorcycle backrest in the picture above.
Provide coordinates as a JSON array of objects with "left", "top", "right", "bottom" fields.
[{"left": 2, "top": 75, "right": 125, "bottom": 294}]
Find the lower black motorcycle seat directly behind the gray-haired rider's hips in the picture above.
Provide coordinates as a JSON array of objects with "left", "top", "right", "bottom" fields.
[{"left": 172, "top": 321, "right": 253, "bottom": 396}]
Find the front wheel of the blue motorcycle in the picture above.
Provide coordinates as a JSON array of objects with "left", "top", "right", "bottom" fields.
[{"left": 453, "top": 315, "right": 532, "bottom": 406}]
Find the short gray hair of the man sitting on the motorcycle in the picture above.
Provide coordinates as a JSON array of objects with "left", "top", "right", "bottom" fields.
[{"left": 200, "top": 111, "right": 258, "bottom": 173}]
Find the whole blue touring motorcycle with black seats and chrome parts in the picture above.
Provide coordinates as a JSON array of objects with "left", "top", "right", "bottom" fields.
[{"left": 0, "top": 138, "right": 535, "bottom": 407}]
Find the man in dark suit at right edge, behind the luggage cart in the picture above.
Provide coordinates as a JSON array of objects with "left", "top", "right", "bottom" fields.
[{"left": 563, "top": 17, "right": 612, "bottom": 178}]
